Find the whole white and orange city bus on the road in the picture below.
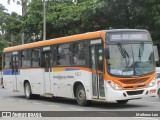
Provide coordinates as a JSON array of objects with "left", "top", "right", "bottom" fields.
[{"left": 3, "top": 29, "right": 157, "bottom": 106}]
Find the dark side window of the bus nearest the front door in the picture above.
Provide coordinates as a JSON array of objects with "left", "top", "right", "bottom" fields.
[{"left": 72, "top": 41, "right": 88, "bottom": 65}]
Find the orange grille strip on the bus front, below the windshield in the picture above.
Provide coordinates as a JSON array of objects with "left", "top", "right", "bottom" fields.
[{"left": 119, "top": 77, "right": 149, "bottom": 84}]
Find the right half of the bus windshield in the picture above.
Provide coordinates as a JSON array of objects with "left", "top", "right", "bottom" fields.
[{"left": 132, "top": 43, "right": 154, "bottom": 75}]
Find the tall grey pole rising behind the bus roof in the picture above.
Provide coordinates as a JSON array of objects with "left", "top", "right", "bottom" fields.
[{"left": 43, "top": 0, "right": 46, "bottom": 40}]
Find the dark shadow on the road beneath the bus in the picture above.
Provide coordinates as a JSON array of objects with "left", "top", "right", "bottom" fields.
[{"left": 12, "top": 96, "right": 149, "bottom": 110}]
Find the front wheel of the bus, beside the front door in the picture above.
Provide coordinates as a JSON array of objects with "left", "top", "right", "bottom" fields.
[{"left": 76, "top": 84, "right": 87, "bottom": 106}]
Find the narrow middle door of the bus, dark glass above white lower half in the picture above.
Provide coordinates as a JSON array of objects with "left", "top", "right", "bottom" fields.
[{"left": 42, "top": 51, "right": 51, "bottom": 93}]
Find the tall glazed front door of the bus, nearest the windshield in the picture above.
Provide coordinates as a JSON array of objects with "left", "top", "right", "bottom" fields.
[{"left": 90, "top": 45, "right": 105, "bottom": 99}]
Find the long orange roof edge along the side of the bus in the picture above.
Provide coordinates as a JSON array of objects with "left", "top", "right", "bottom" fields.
[{"left": 3, "top": 31, "right": 105, "bottom": 53}]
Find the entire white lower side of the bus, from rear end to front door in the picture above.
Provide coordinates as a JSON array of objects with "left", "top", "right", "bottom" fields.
[{"left": 3, "top": 68, "right": 92, "bottom": 100}]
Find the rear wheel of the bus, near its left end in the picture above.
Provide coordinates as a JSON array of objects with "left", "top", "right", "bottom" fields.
[{"left": 24, "top": 82, "right": 33, "bottom": 99}]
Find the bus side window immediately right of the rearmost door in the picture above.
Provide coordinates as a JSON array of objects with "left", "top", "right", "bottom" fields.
[{"left": 21, "top": 50, "right": 31, "bottom": 68}]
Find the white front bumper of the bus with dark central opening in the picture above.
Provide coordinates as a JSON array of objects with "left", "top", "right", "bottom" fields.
[{"left": 105, "top": 86, "right": 157, "bottom": 102}]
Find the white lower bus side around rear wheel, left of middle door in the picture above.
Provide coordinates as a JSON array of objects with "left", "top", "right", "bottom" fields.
[{"left": 3, "top": 69, "right": 44, "bottom": 94}]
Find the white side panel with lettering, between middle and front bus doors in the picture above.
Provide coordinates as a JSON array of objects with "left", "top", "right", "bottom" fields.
[{"left": 50, "top": 68, "right": 92, "bottom": 99}]
